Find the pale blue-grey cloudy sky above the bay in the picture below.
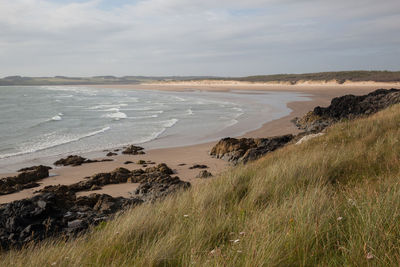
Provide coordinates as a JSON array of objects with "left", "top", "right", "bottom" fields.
[{"left": 0, "top": 0, "right": 400, "bottom": 77}]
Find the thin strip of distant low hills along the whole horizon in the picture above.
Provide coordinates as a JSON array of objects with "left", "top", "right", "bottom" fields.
[{"left": 0, "top": 71, "right": 400, "bottom": 86}]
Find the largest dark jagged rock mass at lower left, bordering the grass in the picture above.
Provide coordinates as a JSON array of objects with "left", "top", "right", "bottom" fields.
[{"left": 0, "top": 163, "right": 190, "bottom": 249}]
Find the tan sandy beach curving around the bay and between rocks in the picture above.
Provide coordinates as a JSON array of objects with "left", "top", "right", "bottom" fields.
[{"left": 0, "top": 81, "right": 400, "bottom": 203}]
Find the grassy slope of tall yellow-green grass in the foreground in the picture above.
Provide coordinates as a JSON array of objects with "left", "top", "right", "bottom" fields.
[{"left": 0, "top": 105, "right": 400, "bottom": 266}]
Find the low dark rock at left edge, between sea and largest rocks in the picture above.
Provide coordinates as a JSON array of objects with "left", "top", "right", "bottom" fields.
[{"left": 0, "top": 165, "right": 51, "bottom": 195}]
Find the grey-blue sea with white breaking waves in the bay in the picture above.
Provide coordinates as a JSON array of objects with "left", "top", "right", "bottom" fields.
[{"left": 0, "top": 86, "right": 307, "bottom": 171}]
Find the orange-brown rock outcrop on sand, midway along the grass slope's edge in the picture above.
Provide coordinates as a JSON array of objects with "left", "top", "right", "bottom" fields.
[{"left": 210, "top": 134, "right": 294, "bottom": 164}]
